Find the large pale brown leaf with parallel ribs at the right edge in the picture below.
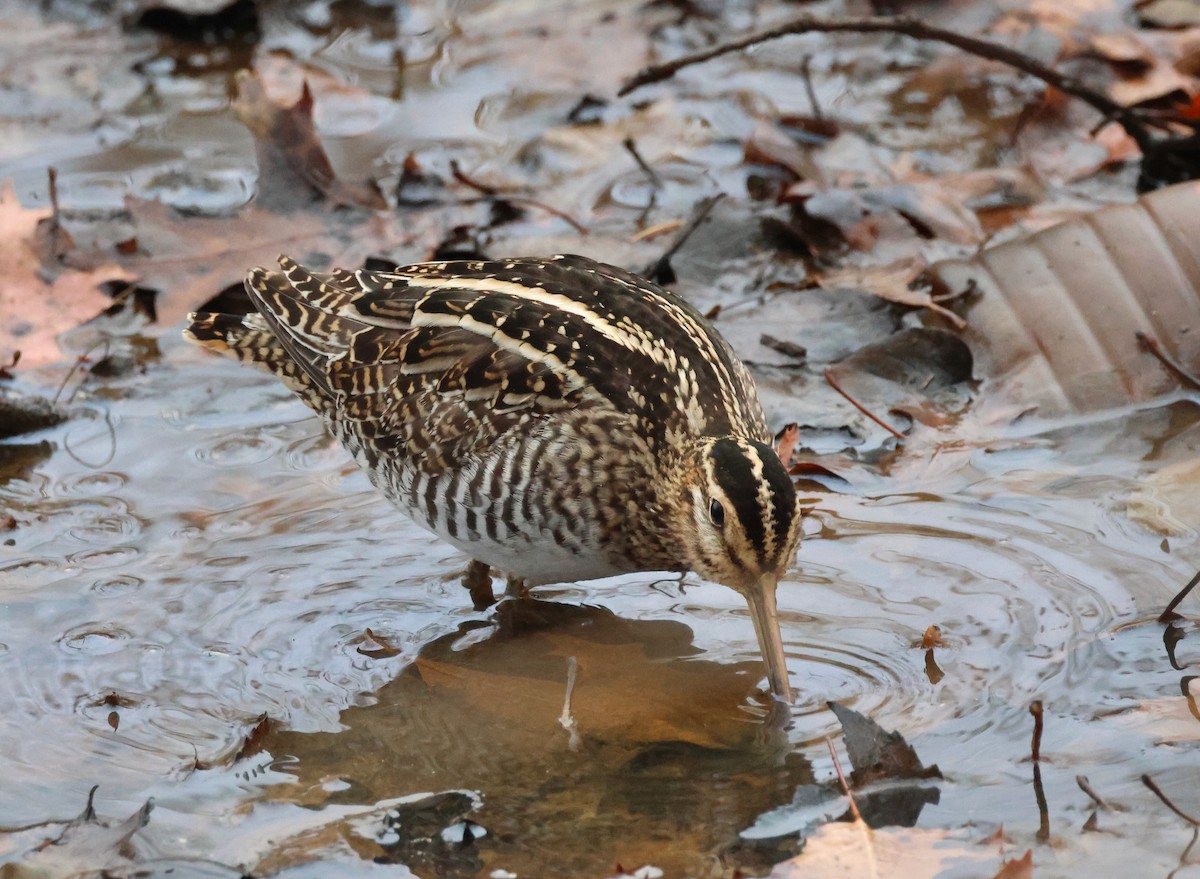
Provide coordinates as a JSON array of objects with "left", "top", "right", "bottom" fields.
[{"left": 931, "top": 181, "right": 1200, "bottom": 415}]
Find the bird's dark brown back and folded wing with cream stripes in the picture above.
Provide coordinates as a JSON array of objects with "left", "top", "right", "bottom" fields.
[{"left": 219, "top": 257, "right": 763, "bottom": 466}]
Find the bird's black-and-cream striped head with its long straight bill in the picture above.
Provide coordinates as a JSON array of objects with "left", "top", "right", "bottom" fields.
[{"left": 673, "top": 436, "right": 800, "bottom": 701}]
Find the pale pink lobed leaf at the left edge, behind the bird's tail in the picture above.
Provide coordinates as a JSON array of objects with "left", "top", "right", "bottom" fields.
[{"left": 0, "top": 180, "right": 133, "bottom": 366}]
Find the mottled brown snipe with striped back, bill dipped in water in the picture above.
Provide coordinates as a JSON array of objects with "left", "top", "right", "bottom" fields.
[{"left": 186, "top": 256, "right": 799, "bottom": 698}]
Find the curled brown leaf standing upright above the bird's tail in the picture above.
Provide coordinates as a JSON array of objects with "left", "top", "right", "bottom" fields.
[{"left": 233, "top": 71, "right": 388, "bottom": 210}]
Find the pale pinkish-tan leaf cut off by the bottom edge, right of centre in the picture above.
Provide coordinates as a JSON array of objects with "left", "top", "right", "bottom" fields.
[{"left": 770, "top": 821, "right": 996, "bottom": 879}]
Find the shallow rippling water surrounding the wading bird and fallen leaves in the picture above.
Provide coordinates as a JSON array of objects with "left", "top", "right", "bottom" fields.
[{"left": 0, "top": 2, "right": 1200, "bottom": 879}]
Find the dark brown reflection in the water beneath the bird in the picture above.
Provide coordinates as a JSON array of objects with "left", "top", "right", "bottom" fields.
[{"left": 263, "top": 600, "right": 812, "bottom": 875}]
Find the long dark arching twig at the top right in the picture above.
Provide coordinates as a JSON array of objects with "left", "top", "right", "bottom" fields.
[{"left": 617, "top": 16, "right": 1156, "bottom": 154}]
